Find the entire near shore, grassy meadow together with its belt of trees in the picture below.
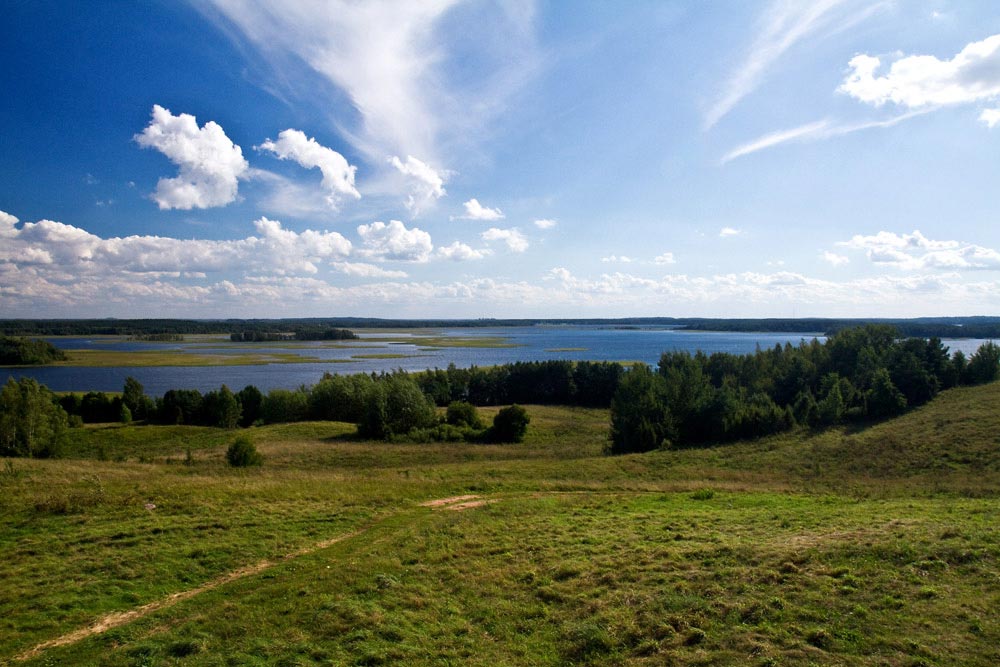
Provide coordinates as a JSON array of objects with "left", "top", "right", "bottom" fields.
[{"left": 0, "top": 327, "right": 1000, "bottom": 666}]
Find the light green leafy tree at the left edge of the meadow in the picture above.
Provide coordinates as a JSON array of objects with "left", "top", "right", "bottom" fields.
[{"left": 0, "top": 378, "right": 67, "bottom": 458}]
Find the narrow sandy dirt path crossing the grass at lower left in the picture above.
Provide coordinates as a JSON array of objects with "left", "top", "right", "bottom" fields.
[{"left": 14, "top": 495, "right": 495, "bottom": 662}]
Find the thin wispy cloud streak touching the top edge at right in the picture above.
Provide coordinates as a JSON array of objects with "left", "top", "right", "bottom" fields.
[{"left": 705, "top": 0, "right": 886, "bottom": 129}]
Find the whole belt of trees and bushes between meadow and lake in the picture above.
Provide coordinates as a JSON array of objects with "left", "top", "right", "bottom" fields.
[{"left": 0, "top": 325, "right": 1000, "bottom": 462}]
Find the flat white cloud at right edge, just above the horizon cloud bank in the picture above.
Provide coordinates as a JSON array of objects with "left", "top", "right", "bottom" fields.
[{"left": 838, "top": 230, "right": 1000, "bottom": 270}]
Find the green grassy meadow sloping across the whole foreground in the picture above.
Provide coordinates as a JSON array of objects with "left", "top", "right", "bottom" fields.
[{"left": 0, "top": 384, "right": 1000, "bottom": 666}]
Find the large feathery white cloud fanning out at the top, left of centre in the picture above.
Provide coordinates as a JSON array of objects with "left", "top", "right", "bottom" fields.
[{"left": 197, "top": 0, "right": 538, "bottom": 163}]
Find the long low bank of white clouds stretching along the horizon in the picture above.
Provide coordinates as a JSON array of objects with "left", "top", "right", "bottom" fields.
[{"left": 0, "top": 207, "right": 1000, "bottom": 317}]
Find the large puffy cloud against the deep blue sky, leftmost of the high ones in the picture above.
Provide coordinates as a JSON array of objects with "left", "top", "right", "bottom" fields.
[{"left": 133, "top": 104, "right": 250, "bottom": 210}]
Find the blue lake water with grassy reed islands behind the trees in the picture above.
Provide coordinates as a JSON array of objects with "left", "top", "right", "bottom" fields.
[{"left": 0, "top": 326, "right": 985, "bottom": 396}]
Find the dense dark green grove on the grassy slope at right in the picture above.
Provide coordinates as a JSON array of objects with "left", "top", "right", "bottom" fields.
[{"left": 610, "top": 325, "right": 1000, "bottom": 454}]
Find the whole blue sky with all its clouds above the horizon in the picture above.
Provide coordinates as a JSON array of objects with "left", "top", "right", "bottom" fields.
[{"left": 0, "top": 0, "right": 1000, "bottom": 318}]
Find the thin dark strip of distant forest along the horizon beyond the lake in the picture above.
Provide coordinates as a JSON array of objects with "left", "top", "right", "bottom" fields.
[{"left": 0, "top": 317, "right": 1000, "bottom": 340}]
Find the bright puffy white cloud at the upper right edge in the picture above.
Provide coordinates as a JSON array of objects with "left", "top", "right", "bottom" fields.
[{"left": 839, "top": 35, "right": 1000, "bottom": 109}]
